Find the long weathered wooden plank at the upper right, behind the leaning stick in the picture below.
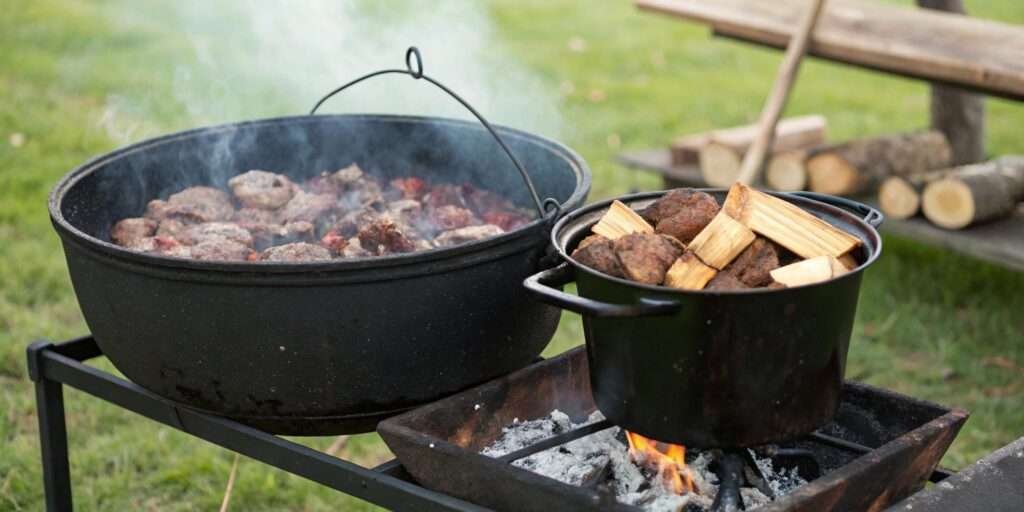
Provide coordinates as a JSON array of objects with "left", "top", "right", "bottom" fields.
[{"left": 635, "top": 0, "right": 1024, "bottom": 99}]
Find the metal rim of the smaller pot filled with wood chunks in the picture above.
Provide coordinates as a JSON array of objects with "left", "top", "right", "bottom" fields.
[{"left": 551, "top": 188, "right": 882, "bottom": 296}]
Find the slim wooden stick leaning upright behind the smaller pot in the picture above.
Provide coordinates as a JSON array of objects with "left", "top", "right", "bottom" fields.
[{"left": 737, "top": 0, "right": 825, "bottom": 184}]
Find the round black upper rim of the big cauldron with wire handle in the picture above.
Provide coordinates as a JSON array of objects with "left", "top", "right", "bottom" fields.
[{"left": 48, "top": 114, "right": 591, "bottom": 278}]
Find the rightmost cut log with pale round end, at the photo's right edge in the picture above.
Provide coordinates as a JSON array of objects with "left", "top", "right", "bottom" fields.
[{"left": 922, "top": 156, "right": 1024, "bottom": 229}]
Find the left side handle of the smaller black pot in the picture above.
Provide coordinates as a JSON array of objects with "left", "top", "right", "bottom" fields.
[{"left": 522, "top": 263, "right": 680, "bottom": 317}]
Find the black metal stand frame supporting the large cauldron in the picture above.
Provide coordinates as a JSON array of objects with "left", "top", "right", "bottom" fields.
[{"left": 28, "top": 337, "right": 488, "bottom": 512}]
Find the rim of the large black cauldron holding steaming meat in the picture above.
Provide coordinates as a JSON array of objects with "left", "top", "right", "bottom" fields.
[{"left": 47, "top": 115, "right": 591, "bottom": 283}]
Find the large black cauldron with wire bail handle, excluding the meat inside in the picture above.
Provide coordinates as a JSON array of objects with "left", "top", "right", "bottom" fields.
[{"left": 49, "top": 48, "right": 590, "bottom": 434}]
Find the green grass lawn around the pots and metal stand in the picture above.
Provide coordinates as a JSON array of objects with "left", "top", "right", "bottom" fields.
[{"left": 0, "top": 0, "right": 1024, "bottom": 510}]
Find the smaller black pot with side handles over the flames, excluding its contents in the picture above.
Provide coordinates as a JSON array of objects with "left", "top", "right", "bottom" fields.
[{"left": 524, "top": 189, "right": 883, "bottom": 447}]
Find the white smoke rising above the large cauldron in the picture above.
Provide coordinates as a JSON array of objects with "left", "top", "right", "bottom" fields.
[{"left": 92, "top": 0, "right": 562, "bottom": 143}]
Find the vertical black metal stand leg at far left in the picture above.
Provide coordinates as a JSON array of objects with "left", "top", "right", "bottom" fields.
[{"left": 29, "top": 343, "right": 73, "bottom": 512}]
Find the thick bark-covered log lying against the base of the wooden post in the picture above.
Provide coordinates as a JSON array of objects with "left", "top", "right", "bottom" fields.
[{"left": 807, "top": 131, "right": 952, "bottom": 196}]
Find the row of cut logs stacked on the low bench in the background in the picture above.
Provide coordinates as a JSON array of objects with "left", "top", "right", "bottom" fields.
[{"left": 671, "top": 121, "right": 1024, "bottom": 229}]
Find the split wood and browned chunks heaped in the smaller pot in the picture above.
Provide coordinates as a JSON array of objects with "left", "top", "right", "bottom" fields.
[{"left": 572, "top": 183, "right": 860, "bottom": 291}]
